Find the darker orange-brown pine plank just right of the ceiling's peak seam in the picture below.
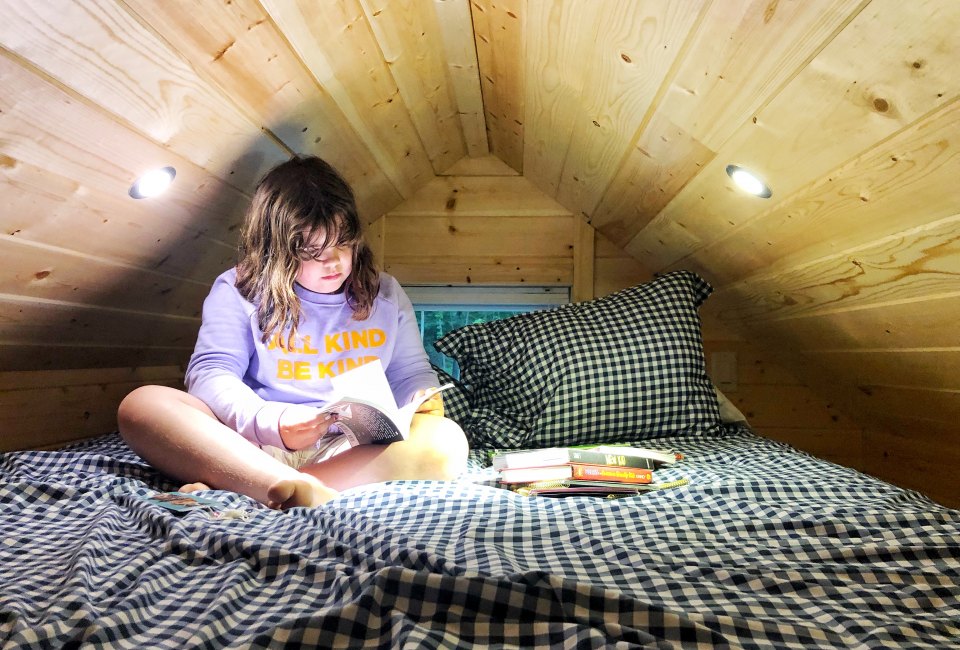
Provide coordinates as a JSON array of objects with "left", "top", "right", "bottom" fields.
[{"left": 470, "top": 0, "right": 525, "bottom": 172}]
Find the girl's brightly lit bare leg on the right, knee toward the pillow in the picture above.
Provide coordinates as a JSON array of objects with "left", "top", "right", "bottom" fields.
[{"left": 300, "top": 414, "right": 468, "bottom": 490}]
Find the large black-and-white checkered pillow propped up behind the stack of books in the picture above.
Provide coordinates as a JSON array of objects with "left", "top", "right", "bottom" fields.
[{"left": 435, "top": 271, "right": 721, "bottom": 449}]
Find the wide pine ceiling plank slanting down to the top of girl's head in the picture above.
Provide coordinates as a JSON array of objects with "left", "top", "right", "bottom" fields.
[{"left": 122, "top": 0, "right": 402, "bottom": 221}]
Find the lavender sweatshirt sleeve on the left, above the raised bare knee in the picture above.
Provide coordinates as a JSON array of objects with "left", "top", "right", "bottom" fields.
[{"left": 186, "top": 273, "right": 287, "bottom": 449}]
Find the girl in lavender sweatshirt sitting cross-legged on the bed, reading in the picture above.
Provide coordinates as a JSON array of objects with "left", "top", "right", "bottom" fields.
[{"left": 118, "top": 157, "right": 467, "bottom": 508}]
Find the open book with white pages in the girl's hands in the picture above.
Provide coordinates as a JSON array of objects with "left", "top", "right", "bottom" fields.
[{"left": 321, "top": 359, "right": 453, "bottom": 447}]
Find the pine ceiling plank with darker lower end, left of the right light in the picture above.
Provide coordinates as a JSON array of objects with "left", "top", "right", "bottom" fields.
[{"left": 591, "top": 0, "right": 865, "bottom": 246}]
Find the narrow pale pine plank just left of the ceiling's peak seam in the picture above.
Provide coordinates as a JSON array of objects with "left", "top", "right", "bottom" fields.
[{"left": 433, "top": 0, "right": 490, "bottom": 157}]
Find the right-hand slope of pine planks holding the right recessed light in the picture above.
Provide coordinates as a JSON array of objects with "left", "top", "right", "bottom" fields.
[{"left": 466, "top": 0, "right": 960, "bottom": 504}]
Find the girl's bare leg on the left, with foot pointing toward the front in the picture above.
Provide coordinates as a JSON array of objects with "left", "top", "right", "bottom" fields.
[{"left": 117, "top": 386, "right": 337, "bottom": 508}]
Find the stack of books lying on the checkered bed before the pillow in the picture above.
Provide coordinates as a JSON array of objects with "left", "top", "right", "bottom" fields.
[{"left": 493, "top": 446, "right": 687, "bottom": 497}]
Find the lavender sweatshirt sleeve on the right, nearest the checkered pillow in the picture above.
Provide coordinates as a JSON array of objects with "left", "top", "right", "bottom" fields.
[{"left": 382, "top": 276, "right": 440, "bottom": 406}]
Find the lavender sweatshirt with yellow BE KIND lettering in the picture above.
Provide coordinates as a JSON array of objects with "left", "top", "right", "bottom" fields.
[{"left": 186, "top": 269, "right": 438, "bottom": 448}]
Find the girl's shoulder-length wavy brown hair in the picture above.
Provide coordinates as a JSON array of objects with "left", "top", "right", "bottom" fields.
[{"left": 236, "top": 156, "right": 380, "bottom": 344}]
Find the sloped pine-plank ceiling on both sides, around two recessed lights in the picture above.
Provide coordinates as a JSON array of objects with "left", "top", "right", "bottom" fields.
[{"left": 0, "top": 0, "right": 960, "bottom": 466}]
